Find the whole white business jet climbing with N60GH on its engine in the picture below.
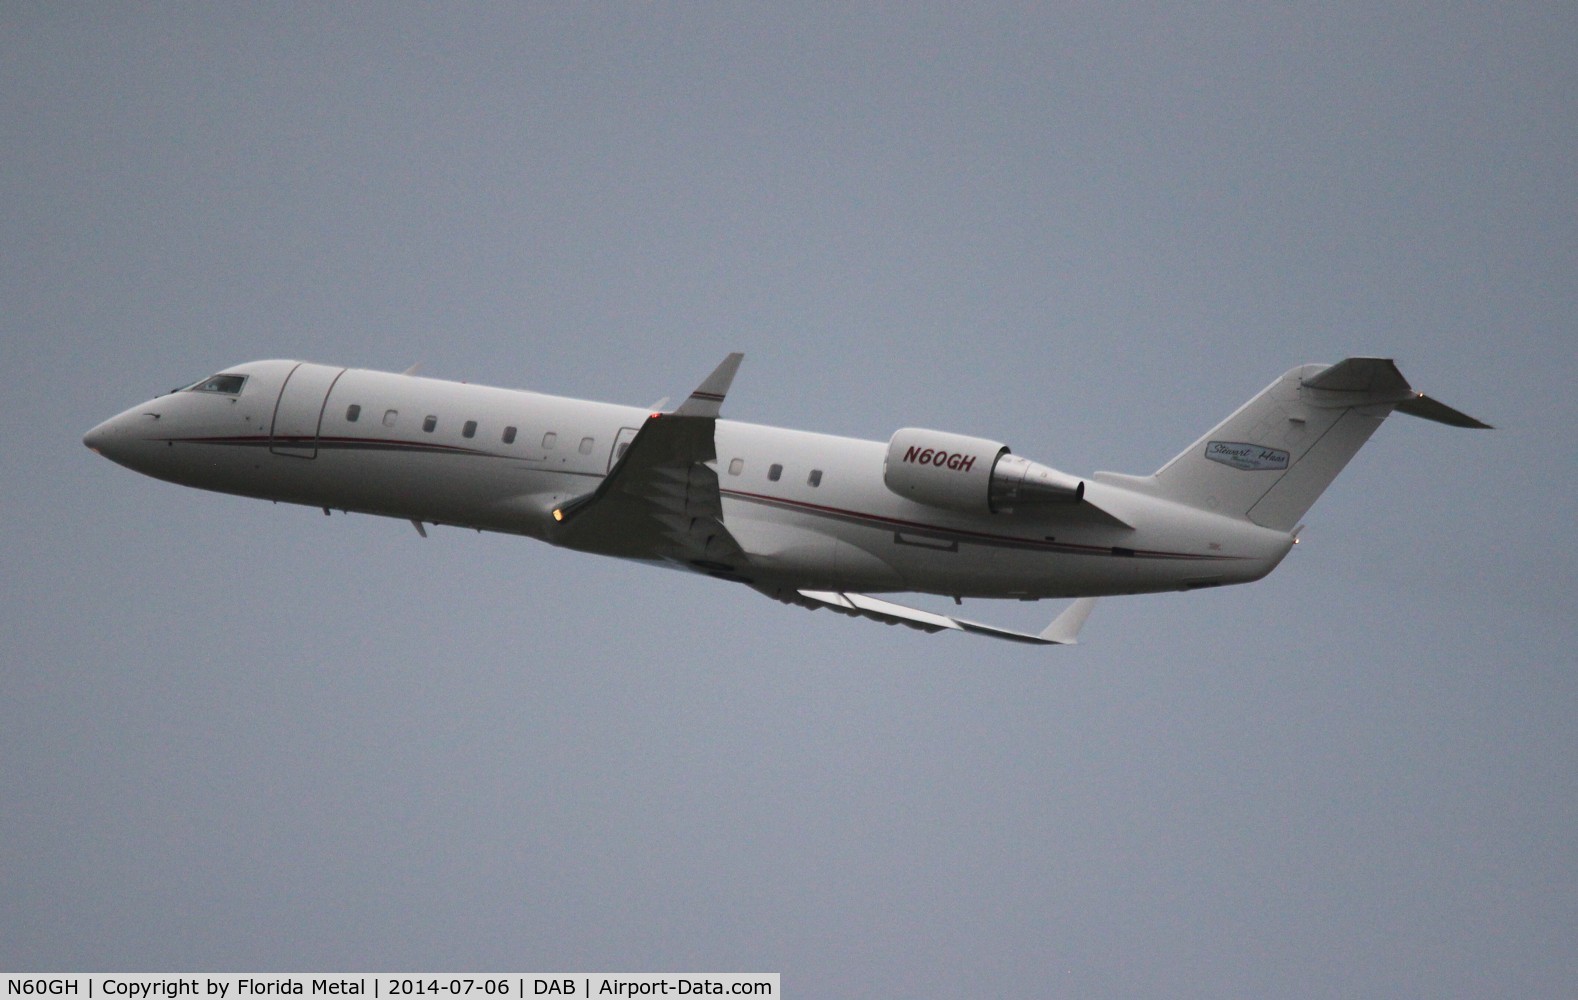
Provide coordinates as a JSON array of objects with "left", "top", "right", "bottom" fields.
[{"left": 82, "top": 353, "right": 1486, "bottom": 644}]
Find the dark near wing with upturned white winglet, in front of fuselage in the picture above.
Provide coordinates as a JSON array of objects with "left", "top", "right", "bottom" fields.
[{"left": 554, "top": 353, "right": 748, "bottom": 579}]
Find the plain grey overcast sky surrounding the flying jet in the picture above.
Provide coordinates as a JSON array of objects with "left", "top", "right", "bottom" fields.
[{"left": 0, "top": 2, "right": 1578, "bottom": 997}]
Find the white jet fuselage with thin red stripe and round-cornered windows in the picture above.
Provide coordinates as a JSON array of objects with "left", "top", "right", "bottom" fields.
[{"left": 85, "top": 361, "right": 1294, "bottom": 599}]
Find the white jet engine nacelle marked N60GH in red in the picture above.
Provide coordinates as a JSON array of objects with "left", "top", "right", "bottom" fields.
[{"left": 882, "top": 427, "right": 1084, "bottom": 514}]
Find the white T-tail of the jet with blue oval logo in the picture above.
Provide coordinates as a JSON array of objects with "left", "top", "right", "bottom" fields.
[{"left": 1098, "top": 358, "right": 1490, "bottom": 532}]
